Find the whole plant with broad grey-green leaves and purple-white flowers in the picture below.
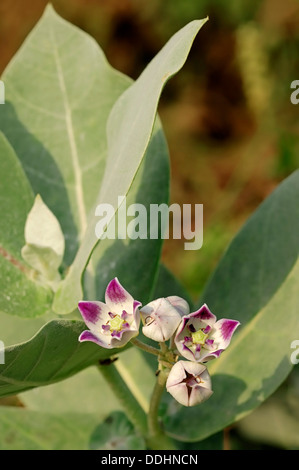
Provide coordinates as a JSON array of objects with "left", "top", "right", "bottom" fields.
[{"left": 0, "top": 6, "right": 299, "bottom": 449}]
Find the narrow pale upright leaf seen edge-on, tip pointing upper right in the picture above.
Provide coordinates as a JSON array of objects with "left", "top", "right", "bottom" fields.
[{"left": 53, "top": 16, "right": 206, "bottom": 314}]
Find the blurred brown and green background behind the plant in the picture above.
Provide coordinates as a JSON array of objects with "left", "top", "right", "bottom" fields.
[{"left": 0, "top": 0, "right": 299, "bottom": 448}]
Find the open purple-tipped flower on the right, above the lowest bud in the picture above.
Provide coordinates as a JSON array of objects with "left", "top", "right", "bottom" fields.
[{"left": 175, "top": 304, "right": 240, "bottom": 362}]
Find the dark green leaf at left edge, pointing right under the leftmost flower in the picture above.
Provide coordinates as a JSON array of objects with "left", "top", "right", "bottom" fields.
[{"left": 0, "top": 320, "right": 128, "bottom": 396}]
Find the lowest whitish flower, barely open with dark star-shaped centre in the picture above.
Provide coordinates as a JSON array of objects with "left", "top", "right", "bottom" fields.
[{"left": 166, "top": 361, "right": 213, "bottom": 406}]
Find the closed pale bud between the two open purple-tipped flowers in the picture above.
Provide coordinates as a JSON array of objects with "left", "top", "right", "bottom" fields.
[{"left": 140, "top": 296, "right": 190, "bottom": 342}]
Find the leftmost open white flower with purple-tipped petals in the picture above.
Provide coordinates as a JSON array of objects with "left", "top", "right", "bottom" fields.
[{"left": 78, "top": 278, "right": 141, "bottom": 349}]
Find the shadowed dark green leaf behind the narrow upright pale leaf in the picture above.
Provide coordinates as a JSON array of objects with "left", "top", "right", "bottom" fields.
[{"left": 84, "top": 124, "right": 169, "bottom": 304}]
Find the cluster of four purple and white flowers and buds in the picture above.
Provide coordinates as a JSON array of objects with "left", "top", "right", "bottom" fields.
[{"left": 78, "top": 278, "right": 239, "bottom": 406}]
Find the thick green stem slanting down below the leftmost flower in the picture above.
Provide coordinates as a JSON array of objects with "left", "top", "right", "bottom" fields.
[{"left": 98, "top": 363, "right": 147, "bottom": 438}]
